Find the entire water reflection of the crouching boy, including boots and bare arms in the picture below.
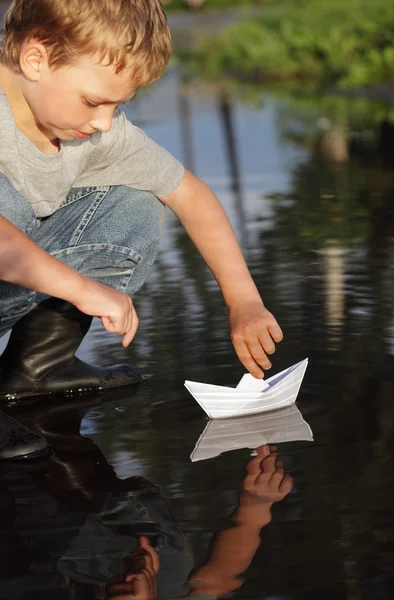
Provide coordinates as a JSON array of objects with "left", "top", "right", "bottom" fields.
[{"left": 0, "top": 399, "right": 292, "bottom": 600}]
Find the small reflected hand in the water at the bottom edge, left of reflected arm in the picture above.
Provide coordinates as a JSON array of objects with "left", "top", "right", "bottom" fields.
[{"left": 106, "top": 536, "right": 160, "bottom": 600}]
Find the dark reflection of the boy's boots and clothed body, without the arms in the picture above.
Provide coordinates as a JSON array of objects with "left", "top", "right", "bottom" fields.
[{"left": 0, "top": 408, "right": 193, "bottom": 600}]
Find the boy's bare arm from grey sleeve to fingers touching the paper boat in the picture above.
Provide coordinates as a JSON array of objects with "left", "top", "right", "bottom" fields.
[{"left": 160, "top": 170, "right": 283, "bottom": 377}]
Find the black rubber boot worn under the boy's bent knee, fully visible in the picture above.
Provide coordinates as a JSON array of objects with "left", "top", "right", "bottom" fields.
[{"left": 0, "top": 298, "right": 142, "bottom": 402}]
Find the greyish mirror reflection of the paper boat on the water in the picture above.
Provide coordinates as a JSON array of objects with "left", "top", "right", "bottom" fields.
[{"left": 190, "top": 406, "right": 313, "bottom": 462}]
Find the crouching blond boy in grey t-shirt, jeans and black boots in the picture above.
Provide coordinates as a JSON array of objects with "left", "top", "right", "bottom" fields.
[{"left": 0, "top": 0, "right": 282, "bottom": 406}]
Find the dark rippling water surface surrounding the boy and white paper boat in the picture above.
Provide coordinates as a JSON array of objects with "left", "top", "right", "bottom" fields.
[{"left": 0, "top": 3, "right": 394, "bottom": 600}]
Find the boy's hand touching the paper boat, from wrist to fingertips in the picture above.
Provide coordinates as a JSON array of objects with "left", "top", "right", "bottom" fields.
[{"left": 229, "top": 302, "right": 283, "bottom": 378}]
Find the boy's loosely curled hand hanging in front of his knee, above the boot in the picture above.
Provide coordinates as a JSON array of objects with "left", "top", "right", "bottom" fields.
[{"left": 70, "top": 278, "right": 138, "bottom": 348}]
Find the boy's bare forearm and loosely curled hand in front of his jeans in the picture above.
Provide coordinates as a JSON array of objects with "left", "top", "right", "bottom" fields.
[{"left": 0, "top": 217, "right": 138, "bottom": 346}]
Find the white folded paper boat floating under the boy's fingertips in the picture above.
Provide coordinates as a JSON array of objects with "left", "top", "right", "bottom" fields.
[{"left": 185, "top": 358, "right": 308, "bottom": 419}]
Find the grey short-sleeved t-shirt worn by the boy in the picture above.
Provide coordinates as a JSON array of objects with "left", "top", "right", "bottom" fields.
[{"left": 0, "top": 88, "right": 184, "bottom": 217}]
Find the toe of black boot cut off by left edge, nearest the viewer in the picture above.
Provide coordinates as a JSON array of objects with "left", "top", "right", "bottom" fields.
[{"left": 0, "top": 411, "right": 52, "bottom": 461}]
